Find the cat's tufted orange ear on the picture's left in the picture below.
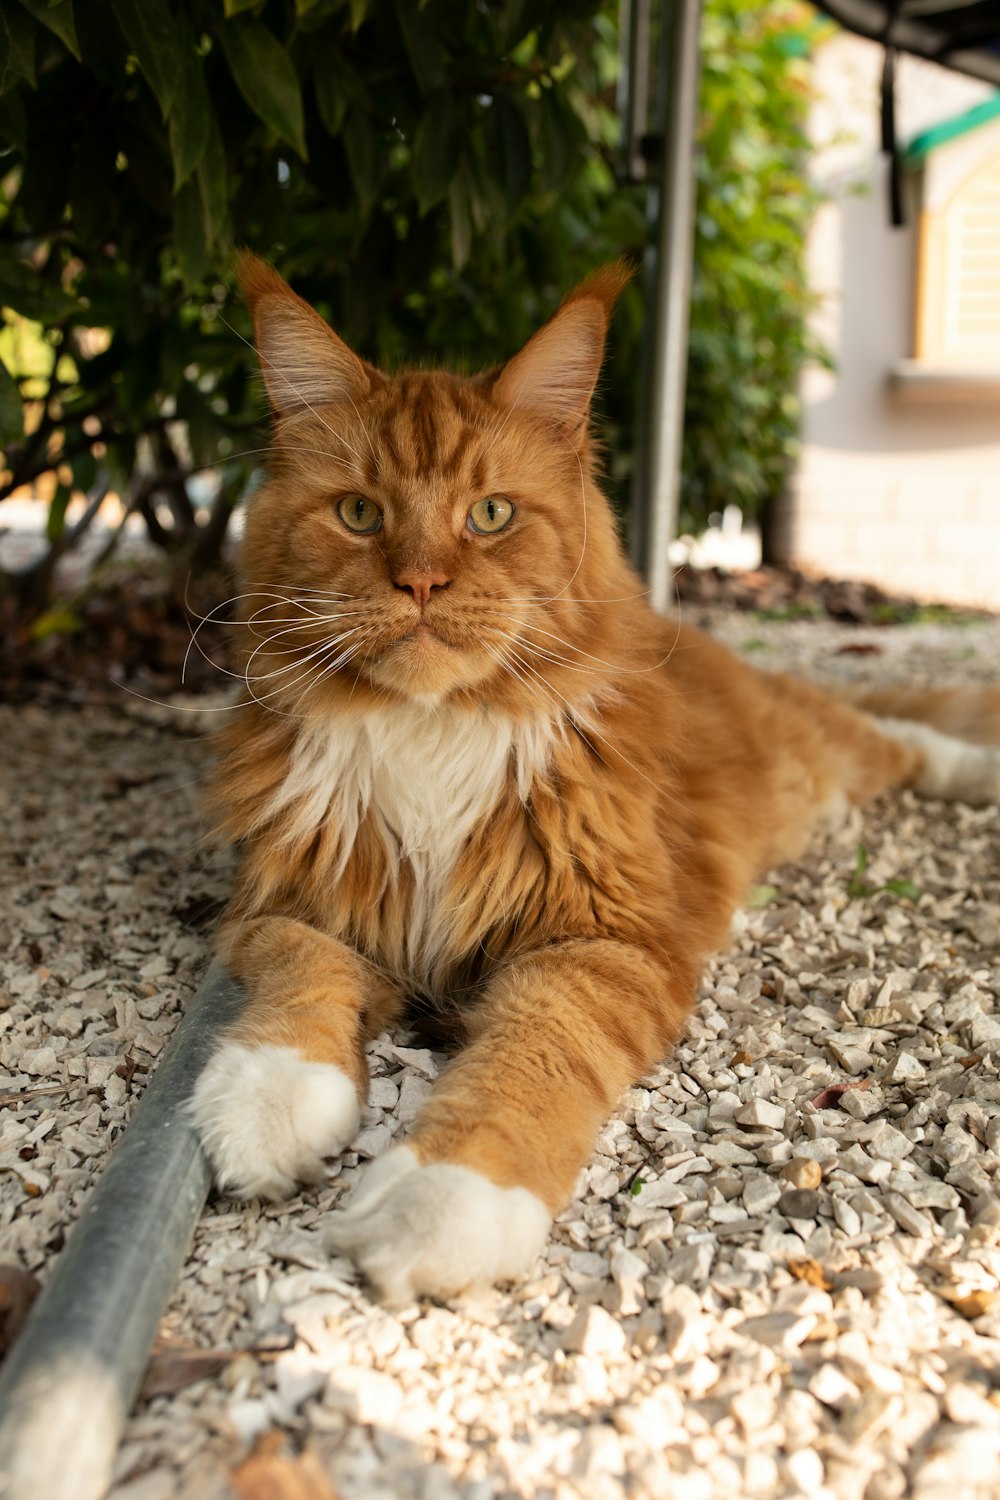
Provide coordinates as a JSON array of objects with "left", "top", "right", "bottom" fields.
[{"left": 237, "top": 251, "right": 378, "bottom": 416}]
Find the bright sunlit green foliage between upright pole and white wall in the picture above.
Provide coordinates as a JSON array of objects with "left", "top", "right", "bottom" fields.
[{"left": 682, "top": 0, "right": 826, "bottom": 528}]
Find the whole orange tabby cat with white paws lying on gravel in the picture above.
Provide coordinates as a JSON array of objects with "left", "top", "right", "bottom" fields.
[{"left": 195, "top": 257, "right": 1000, "bottom": 1299}]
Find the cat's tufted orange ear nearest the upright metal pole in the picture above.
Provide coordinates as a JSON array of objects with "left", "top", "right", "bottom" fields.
[{"left": 493, "top": 261, "right": 631, "bottom": 443}]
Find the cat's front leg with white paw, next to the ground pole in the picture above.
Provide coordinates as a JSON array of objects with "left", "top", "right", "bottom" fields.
[{"left": 192, "top": 917, "right": 397, "bottom": 1199}]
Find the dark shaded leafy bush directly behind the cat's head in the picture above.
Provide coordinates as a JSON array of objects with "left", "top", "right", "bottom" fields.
[{"left": 0, "top": 0, "right": 643, "bottom": 609}]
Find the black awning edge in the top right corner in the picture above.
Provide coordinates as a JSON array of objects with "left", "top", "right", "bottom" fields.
[{"left": 817, "top": 0, "right": 1000, "bottom": 86}]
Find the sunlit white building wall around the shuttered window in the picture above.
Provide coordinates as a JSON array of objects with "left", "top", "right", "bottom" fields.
[{"left": 786, "top": 36, "right": 1000, "bottom": 608}]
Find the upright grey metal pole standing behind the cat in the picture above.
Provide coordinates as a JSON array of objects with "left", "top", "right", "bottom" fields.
[{"left": 633, "top": 0, "right": 702, "bottom": 611}]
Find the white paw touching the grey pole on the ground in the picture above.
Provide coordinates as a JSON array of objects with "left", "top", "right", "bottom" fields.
[{"left": 190, "top": 1041, "right": 360, "bottom": 1199}]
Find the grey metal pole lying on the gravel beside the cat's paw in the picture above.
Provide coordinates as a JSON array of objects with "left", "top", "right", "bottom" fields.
[{"left": 0, "top": 965, "right": 243, "bottom": 1500}]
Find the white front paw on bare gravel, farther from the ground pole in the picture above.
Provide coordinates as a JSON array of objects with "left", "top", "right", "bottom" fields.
[{"left": 325, "top": 1146, "right": 552, "bottom": 1304}]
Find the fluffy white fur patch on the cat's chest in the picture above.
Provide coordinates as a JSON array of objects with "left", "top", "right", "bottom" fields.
[{"left": 270, "top": 704, "right": 559, "bottom": 978}]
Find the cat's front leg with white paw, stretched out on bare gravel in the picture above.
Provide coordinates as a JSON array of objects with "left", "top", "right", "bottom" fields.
[{"left": 330, "top": 941, "right": 691, "bottom": 1302}]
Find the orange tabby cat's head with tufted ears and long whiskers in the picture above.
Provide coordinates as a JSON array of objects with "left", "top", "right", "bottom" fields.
[{"left": 240, "top": 255, "right": 634, "bottom": 711}]
